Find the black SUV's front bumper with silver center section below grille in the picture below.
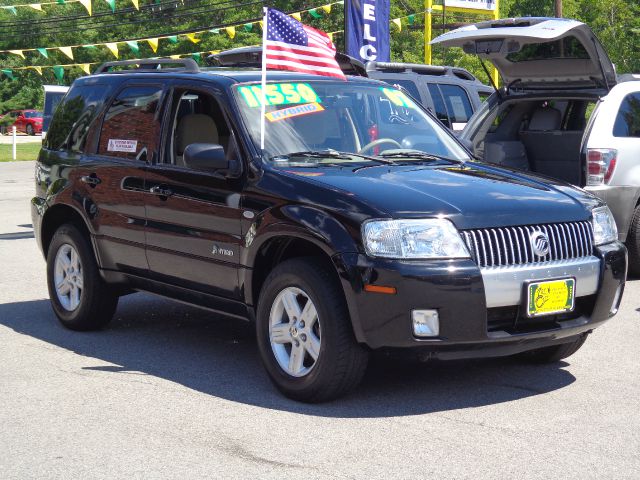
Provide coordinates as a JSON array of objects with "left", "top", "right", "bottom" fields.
[{"left": 334, "top": 242, "right": 627, "bottom": 359}]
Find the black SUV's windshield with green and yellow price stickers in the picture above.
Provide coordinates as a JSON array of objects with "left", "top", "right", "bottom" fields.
[{"left": 235, "top": 80, "right": 468, "bottom": 164}]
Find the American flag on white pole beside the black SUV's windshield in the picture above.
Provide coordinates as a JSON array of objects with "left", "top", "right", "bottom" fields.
[{"left": 264, "top": 8, "right": 345, "bottom": 80}]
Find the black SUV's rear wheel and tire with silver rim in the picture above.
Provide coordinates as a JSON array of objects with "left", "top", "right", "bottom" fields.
[{"left": 47, "top": 224, "right": 118, "bottom": 331}]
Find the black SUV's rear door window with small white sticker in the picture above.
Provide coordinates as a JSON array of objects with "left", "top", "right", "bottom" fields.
[{"left": 98, "top": 86, "right": 162, "bottom": 161}]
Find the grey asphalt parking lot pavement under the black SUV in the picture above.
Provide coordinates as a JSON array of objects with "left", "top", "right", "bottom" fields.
[{"left": 0, "top": 162, "right": 640, "bottom": 479}]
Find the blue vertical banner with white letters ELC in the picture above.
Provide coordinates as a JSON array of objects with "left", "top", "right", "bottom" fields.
[{"left": 346, "top": 0, "right": 391, "bottom": 63}]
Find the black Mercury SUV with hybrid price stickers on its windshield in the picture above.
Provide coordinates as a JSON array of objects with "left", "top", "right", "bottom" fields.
[{"left": 32, "top": 60, "right": 627, "bottom": 401}]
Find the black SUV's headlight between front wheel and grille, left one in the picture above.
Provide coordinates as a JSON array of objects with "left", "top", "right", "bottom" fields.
[{"left": 362, "top": 218, "right": 469, "bottom": 258}]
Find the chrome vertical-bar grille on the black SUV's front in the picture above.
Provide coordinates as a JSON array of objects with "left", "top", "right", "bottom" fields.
[{"left": 461, "top": 222, "right": 593, "bottom": 267}]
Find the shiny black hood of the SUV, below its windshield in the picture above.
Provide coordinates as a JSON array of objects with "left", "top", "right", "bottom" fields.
[{"left": 287, "top": 162, "right": 601, "bottom": 229}]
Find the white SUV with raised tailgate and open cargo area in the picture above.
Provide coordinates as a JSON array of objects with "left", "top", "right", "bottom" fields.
[{"left": 432, "top": 18, "right": 640, "bottom": 275}]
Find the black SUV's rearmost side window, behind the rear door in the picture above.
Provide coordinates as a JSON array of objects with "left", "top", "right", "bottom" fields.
[{"left": 44, "top": 84, "right": 111, "bottom": 152}]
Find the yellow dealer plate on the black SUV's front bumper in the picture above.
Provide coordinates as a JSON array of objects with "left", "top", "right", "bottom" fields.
[{"left": 527, "top": 278, "right": 576, "bottom": 317}]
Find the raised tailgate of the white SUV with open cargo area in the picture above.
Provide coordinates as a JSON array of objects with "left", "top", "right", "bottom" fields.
[{"left": 431, "top": 17, "right": 616, "bottom": 92}]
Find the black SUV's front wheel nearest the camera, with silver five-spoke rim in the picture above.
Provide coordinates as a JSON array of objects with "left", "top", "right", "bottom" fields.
[{"left": 256, "top": 258, "right": 369, "bottom": 403}]
